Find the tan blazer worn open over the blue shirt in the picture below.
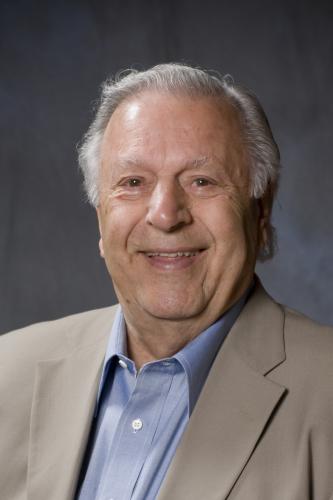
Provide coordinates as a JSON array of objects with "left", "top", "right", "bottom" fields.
[{"left": 0, "top": 285, "right": 333, "bottom": 500}]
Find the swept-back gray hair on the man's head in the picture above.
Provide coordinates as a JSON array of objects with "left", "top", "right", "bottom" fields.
[{"left": 79, "top": 63, "right": 280, "bottom": 260}]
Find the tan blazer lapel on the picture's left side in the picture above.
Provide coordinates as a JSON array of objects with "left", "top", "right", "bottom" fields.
[{"left": 27, "top": 306, "right": 113, "bottom": 500}]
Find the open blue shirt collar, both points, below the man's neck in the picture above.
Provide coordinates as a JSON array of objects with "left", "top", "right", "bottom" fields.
[{"left": 96, "top": 283, "right": 253, "bottom": 414}]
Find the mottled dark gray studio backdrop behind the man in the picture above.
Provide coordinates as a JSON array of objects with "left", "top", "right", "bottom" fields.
[{"left": 0, "top": 0, "right": 333, "bottom": 332}]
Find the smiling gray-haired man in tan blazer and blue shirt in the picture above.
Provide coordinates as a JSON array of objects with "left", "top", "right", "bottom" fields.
[{"left": 0, "top": 64, "right": 333, "bottom": 500}]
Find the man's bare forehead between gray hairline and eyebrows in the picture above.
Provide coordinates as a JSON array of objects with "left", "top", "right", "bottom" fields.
[{"left": 102, "top": 92, "right": 245, "bottom": 175}]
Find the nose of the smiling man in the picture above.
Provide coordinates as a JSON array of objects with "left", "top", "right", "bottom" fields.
[{"left": 146, "top": 180, "right": 192, "bottom": 232}]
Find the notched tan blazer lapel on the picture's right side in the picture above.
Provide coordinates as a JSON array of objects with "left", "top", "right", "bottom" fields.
[{"left": 158, "top": 284, "right": 285, "bottom": 500}]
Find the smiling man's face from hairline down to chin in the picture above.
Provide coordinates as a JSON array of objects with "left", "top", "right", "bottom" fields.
[{"left": 97, "top": 92, "right": 258, "bottom": 321}]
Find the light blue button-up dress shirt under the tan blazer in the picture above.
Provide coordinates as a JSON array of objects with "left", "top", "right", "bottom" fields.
[{"left": 77, "top": 292, "right": 249, "bottom": 500}]
